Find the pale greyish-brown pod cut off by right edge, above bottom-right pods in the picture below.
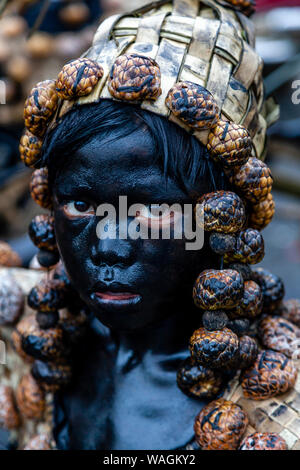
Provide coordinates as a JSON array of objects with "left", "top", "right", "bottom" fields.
[{"left": 258, "top": 316, "right": 300, "bottom": 358}]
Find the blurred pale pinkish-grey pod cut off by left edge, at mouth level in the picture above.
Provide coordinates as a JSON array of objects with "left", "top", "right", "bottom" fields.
[{"left": 0, "top": 274, "right": 25, "bottom": 325}]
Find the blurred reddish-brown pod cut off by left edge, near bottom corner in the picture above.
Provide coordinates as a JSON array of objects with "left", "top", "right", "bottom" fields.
[{"left": 0, "top": 385, "right": 20, "bottom": 429}]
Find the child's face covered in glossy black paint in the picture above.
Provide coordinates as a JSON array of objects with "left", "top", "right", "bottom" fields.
[{"left": 54, "top": 126, "right": 211, "bottom": 330}]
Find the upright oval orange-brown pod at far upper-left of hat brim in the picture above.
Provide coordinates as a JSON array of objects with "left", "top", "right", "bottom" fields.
[{"left": 24, "top": 80, "right": 58, "bottom": 137}]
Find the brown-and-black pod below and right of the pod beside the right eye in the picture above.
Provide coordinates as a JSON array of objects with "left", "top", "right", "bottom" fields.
[{"left": 225, "top": 228, "right": 265, "bottom": 264}]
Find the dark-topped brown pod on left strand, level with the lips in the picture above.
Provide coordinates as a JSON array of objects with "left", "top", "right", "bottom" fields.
[{"left": 28, "top": 279, "right": 66, "bottom": 312}]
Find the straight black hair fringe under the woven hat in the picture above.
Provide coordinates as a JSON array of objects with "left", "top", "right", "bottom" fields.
[{"left": 41, "top": 100, "right": 224, "bottom": 195}]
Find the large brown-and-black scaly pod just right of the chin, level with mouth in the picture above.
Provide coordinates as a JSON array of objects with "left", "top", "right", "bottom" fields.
[{"left": 193, "top": 269, "right": 244, "bottom": 310}]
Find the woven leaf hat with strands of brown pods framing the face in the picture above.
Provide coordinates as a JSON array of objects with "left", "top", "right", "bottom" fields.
[{"left": 0, "top": 0, "right": 300, "bottom": 450}]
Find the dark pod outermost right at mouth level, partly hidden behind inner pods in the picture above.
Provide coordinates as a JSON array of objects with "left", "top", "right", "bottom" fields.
[{"left": 252, "top": 268, "right": 285, "bottom": 312}]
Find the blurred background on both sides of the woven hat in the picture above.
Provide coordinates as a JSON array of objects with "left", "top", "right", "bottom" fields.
[{"left": 0, "top": 0, "right": 300, "bottom": 297}]
